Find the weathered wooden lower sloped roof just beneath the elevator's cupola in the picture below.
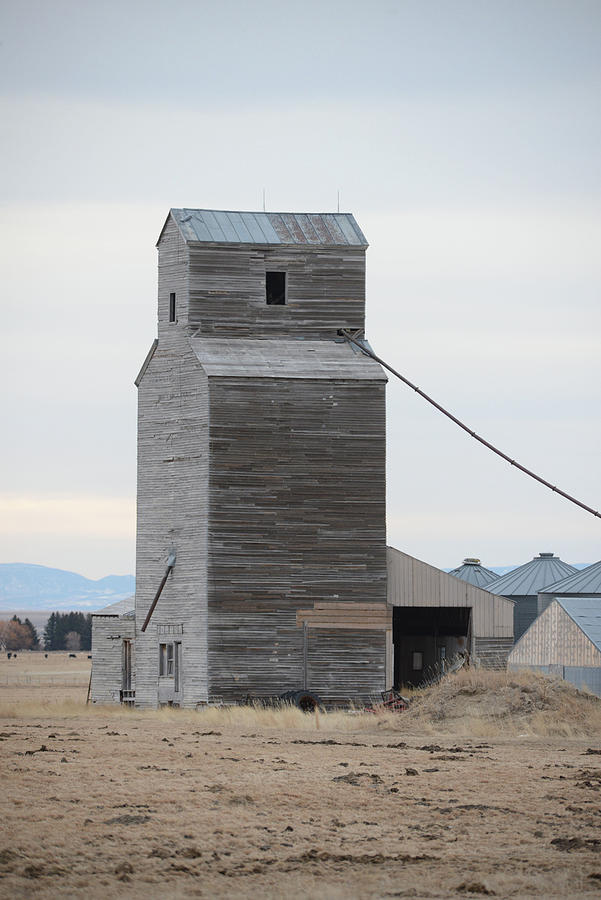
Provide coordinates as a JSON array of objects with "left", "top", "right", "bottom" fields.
[{"left": 190, "top": 338, "right": 387, "bottom": 381}]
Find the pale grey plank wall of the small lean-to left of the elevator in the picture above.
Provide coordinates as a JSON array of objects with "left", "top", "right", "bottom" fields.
[{"left": 90, "top": 615, "right": 135, "bottom": 703}]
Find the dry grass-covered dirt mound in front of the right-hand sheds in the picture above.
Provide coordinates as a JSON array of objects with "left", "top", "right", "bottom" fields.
[{"left": 403, "top": 669, "right": 601, "bottom": 737}]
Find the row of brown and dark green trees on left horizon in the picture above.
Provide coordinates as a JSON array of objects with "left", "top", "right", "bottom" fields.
[{"left": 0, "top": 612, "right": 92, "bottom": 650}]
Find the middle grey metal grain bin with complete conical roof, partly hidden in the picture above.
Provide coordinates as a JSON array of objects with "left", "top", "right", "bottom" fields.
[{"left": 486, "top": 553, "right": 576, "bottom": 641}]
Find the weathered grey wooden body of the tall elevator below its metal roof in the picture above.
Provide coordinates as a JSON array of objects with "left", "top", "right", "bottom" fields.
[{"left": 125, "top": 218, "right": 386, "bottom": 707}]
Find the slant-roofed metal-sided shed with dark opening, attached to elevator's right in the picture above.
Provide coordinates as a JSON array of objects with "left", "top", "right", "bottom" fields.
[{"left": 387, "top": 547, "right": 514, "bottom": 687}]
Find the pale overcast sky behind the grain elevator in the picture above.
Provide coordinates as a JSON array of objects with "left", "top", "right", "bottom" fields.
[{"left": 0, "top": 0, "right": 601, "bottom": 578}]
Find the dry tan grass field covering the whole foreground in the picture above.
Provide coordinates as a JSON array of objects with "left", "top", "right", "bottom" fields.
[{"left": 0, "top": 654, "right": 601, "bottom": 898}]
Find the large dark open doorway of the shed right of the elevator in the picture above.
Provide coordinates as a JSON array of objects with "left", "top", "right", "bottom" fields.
[{"left": 392, "top": 606, "right": 472, "bottom": 689}]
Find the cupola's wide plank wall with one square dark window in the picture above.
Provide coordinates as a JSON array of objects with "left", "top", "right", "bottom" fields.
[{"left": 188, "top": 245, "right": 365, "bottom": 338}]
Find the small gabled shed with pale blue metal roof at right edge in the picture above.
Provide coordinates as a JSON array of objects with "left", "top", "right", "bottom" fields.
[{"left": 508, "top": 597, "right": 601, "bottom": 697}]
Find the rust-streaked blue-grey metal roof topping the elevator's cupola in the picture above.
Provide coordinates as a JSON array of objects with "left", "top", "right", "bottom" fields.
[{"left": 159, "top": 208, "right": 368, "bottom": 247}]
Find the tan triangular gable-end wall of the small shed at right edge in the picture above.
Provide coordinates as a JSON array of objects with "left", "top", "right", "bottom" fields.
[{"left": 509, "top": 600, "right": 601, "bottom": 667}]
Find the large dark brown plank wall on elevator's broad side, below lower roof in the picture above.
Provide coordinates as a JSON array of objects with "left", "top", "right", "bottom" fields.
[{"left": 209, "top": 378, "right": 386, "bottom": 700}]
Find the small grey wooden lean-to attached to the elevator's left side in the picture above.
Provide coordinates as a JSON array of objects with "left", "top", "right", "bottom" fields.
[{"left": 90, "top": 597, "right": 136, "bottom": 703}]
